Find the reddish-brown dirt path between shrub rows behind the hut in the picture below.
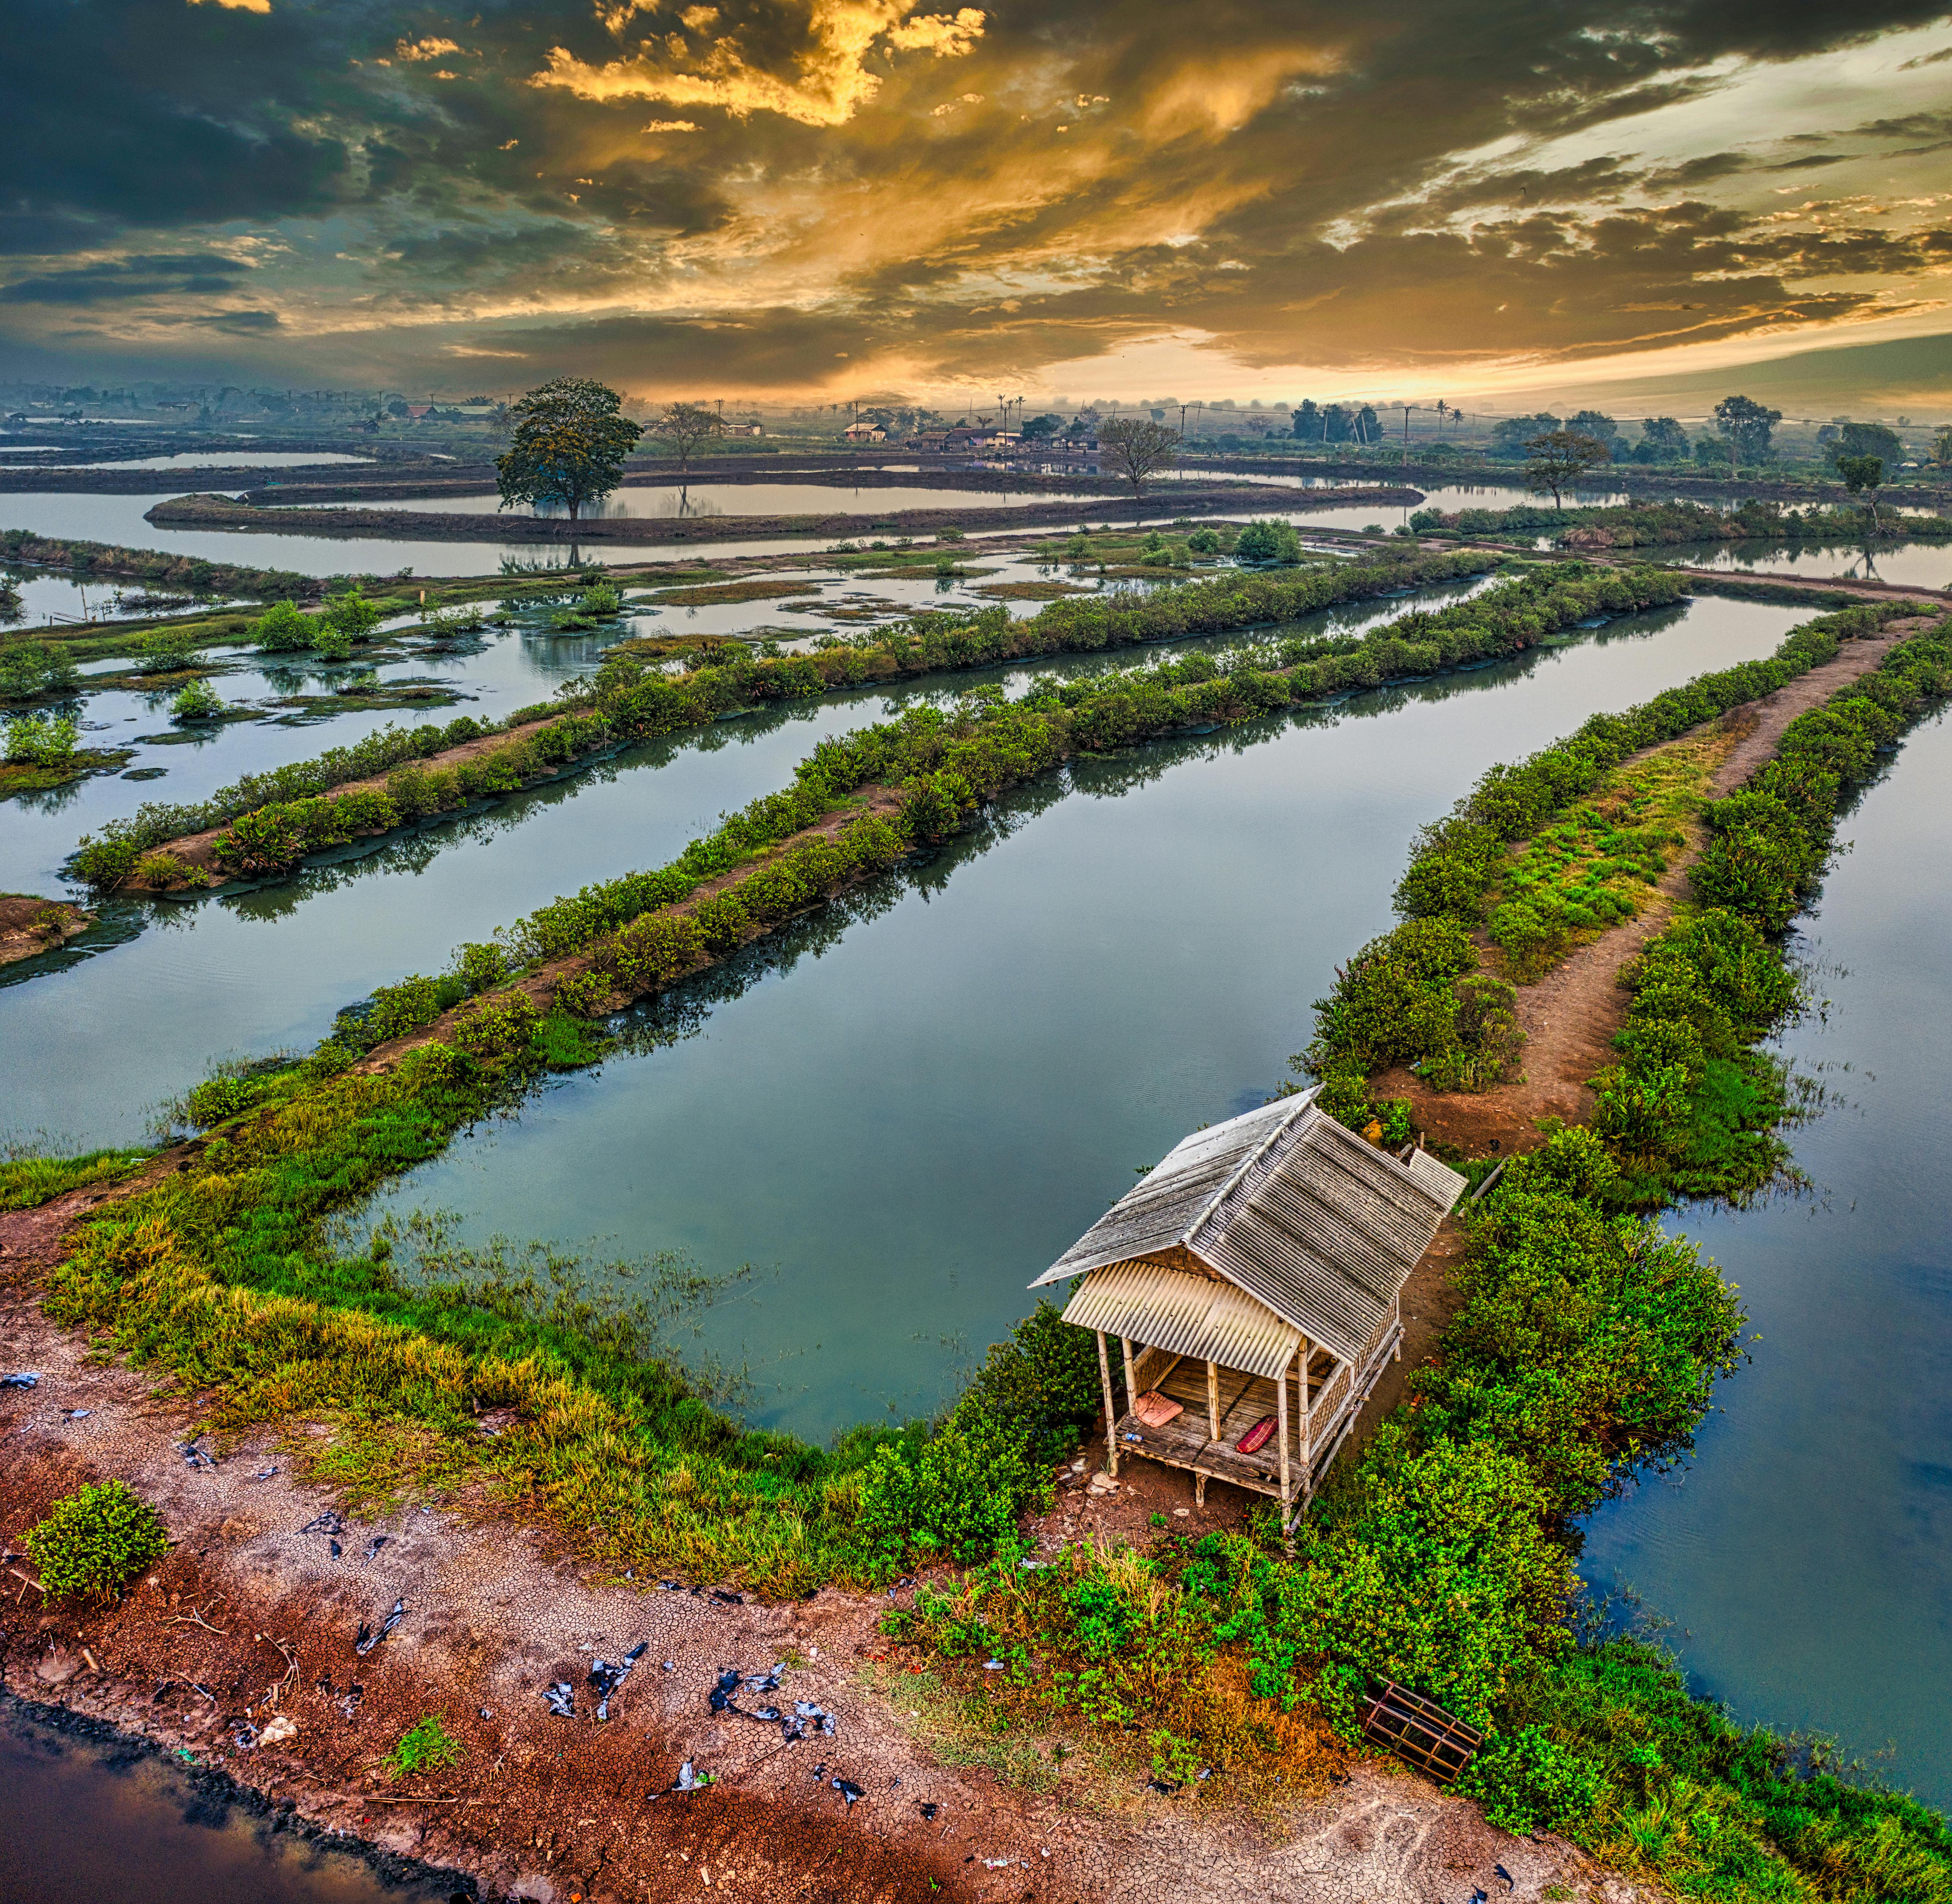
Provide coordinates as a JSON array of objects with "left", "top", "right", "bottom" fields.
[{"left": 1374, "top": 619, "right": 1933, "bottom": 1156}]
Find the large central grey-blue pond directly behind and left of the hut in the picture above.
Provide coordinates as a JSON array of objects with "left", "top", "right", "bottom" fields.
[{"left": 359, "top": 600, "right": 1800, "bottom": 1437}]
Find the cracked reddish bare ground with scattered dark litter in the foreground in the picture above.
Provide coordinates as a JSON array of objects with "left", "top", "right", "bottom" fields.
[{"left": 0, "top": 1265, "right": 1636, "bottom": 1904}]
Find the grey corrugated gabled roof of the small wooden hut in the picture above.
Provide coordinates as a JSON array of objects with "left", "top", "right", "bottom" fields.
[{"left": 1031, "top": 1092, "right": 1464, "bottom": 1373}]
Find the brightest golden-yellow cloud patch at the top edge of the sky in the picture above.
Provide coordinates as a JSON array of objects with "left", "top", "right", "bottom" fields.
[{"left": 529, "top": 0, "right": 984, "bottom": 125}]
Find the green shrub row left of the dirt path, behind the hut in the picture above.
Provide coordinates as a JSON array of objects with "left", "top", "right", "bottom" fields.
[{"left": 1296, "top": 603, "right": 1917, "bottom": 1129}]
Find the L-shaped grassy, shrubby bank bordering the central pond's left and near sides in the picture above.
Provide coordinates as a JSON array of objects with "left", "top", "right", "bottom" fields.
[{"left": 23, "top": 570, "right": 1675, "bottom": 1592}]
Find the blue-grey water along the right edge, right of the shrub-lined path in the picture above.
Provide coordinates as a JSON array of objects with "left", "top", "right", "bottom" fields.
[{"left": 1583, "top": 717, "right": 1952, "bottom": 1808}]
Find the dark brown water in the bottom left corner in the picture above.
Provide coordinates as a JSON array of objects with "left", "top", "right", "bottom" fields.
[{"left": 0, "top": 1701, "right": 455, "bottom": 1904}]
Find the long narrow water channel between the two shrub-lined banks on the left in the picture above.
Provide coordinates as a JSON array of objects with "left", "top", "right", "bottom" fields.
[{"left": 0, "top": 586, "right": 1491, "bottom": 1148}]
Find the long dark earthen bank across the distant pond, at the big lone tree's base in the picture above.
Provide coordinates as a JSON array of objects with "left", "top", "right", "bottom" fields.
[{"left": 144, "top": 482, "right": 1423, "bottom": 545}]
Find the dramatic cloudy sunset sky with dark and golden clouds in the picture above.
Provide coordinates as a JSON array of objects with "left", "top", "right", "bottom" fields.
[{"left": 0, "top": 0, "right": 1952, "bottom": 412}]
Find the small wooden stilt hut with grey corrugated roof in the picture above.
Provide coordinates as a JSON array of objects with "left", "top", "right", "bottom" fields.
[{"left": 1031, "top": 1092, "right": 1466, "bottom": 1533}]
